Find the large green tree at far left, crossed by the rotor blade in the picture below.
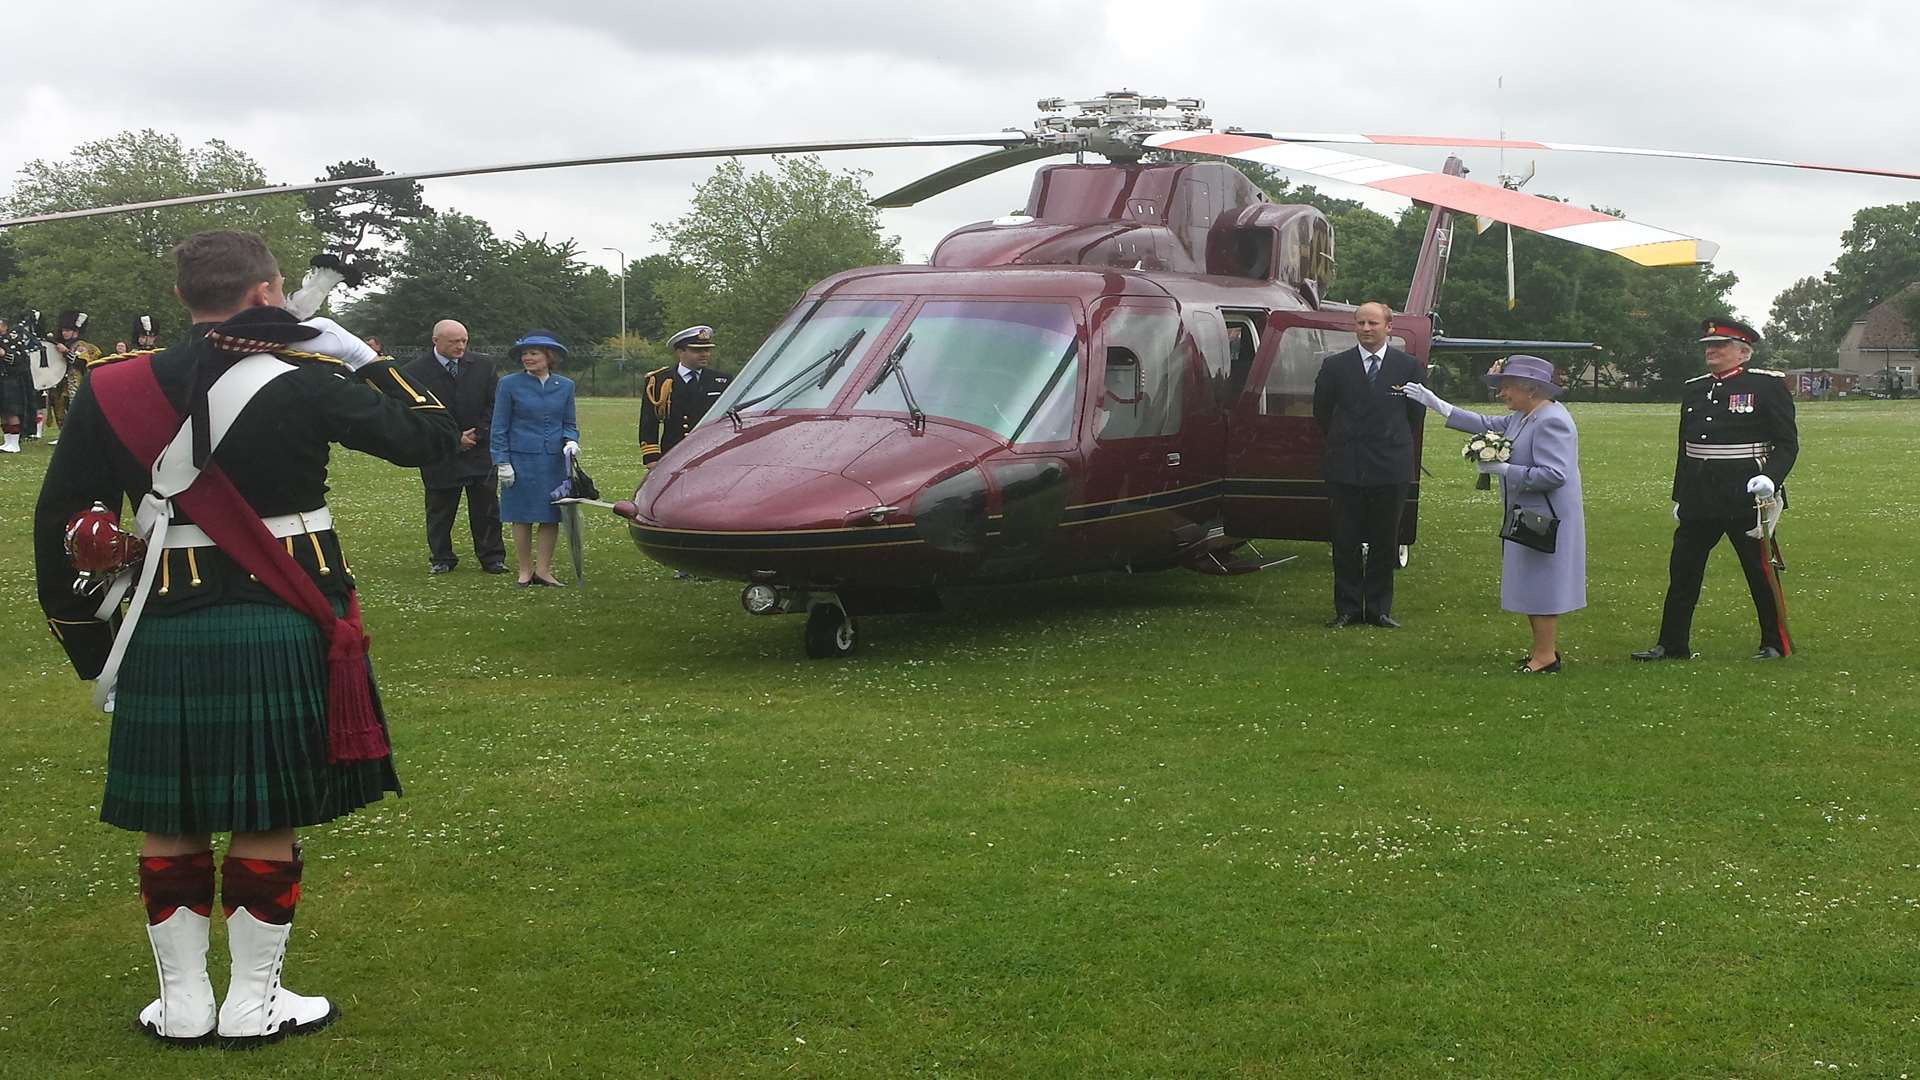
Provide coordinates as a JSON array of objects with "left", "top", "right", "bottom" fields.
[{"left": 0, "top": 129, "right": 321, "bottom": 348}]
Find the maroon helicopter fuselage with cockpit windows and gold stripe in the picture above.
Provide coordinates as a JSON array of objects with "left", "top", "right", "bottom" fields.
[{"left": 630, "top": 161, "right": 1430, "bottom": 613}]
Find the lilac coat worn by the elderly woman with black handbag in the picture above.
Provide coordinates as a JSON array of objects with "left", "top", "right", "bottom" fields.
[{"left": 1446, "top": 402, "right": 1586, "bottom": 615}]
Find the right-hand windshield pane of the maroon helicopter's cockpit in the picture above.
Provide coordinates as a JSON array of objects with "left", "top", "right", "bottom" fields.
[{"left": 867, "top": 300, "right": 1079, "bottom": 444}]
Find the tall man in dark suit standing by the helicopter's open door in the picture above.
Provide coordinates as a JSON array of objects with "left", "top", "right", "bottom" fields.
[{"left": 1313, "top": 304, "right": 1423, "bottom": 628}]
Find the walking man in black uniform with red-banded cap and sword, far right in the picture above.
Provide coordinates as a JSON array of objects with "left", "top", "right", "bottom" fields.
[{"left": 1634, "top": 319, "right": 1799, "bottom": 661}]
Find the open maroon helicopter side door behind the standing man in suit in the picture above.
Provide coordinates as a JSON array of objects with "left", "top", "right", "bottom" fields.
[{"left": 1225, "top": 307, "right": 1427, "bottom": 544}]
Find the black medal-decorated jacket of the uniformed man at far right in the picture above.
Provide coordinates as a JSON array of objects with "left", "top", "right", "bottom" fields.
[{"left": 1672, "top": 367, "right": 1799, "bottom": 519}]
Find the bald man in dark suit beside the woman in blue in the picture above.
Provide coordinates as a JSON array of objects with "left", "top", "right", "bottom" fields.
[{"left": 403, "top": 319, "right": 507, "bottom": 575}]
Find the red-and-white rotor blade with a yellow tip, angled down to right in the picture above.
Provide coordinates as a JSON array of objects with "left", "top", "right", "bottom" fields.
[{"left": 1144, "top": 133, "right": 1720, "bottom": 267}]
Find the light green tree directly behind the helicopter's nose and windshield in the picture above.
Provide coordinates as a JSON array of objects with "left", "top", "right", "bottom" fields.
[{"left": 655, "top": 154, "right": 900, "bottom": 365}]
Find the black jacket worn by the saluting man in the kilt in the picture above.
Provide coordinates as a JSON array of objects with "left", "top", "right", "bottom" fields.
[{"left": 33, "top": 323, "right": 459, "bottom": 678}]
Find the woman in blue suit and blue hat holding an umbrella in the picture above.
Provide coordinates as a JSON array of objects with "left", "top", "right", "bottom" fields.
[{"left": 490, "top": 331, "right": 580, "bottom": 586}]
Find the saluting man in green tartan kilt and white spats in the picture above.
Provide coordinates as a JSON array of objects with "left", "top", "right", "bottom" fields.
[{"left": 35, "top": 231, "right": 457, "bottom": 1043}]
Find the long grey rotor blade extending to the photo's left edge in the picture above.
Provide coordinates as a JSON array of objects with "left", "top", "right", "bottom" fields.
[{"left": 0, "top": 131, "right": 1029, "bottom": 229}]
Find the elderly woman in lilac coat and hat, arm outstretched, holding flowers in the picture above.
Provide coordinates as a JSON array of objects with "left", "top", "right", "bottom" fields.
[{"left": 1404, "top": 356, "right": 1586, "bottom": 675}]
